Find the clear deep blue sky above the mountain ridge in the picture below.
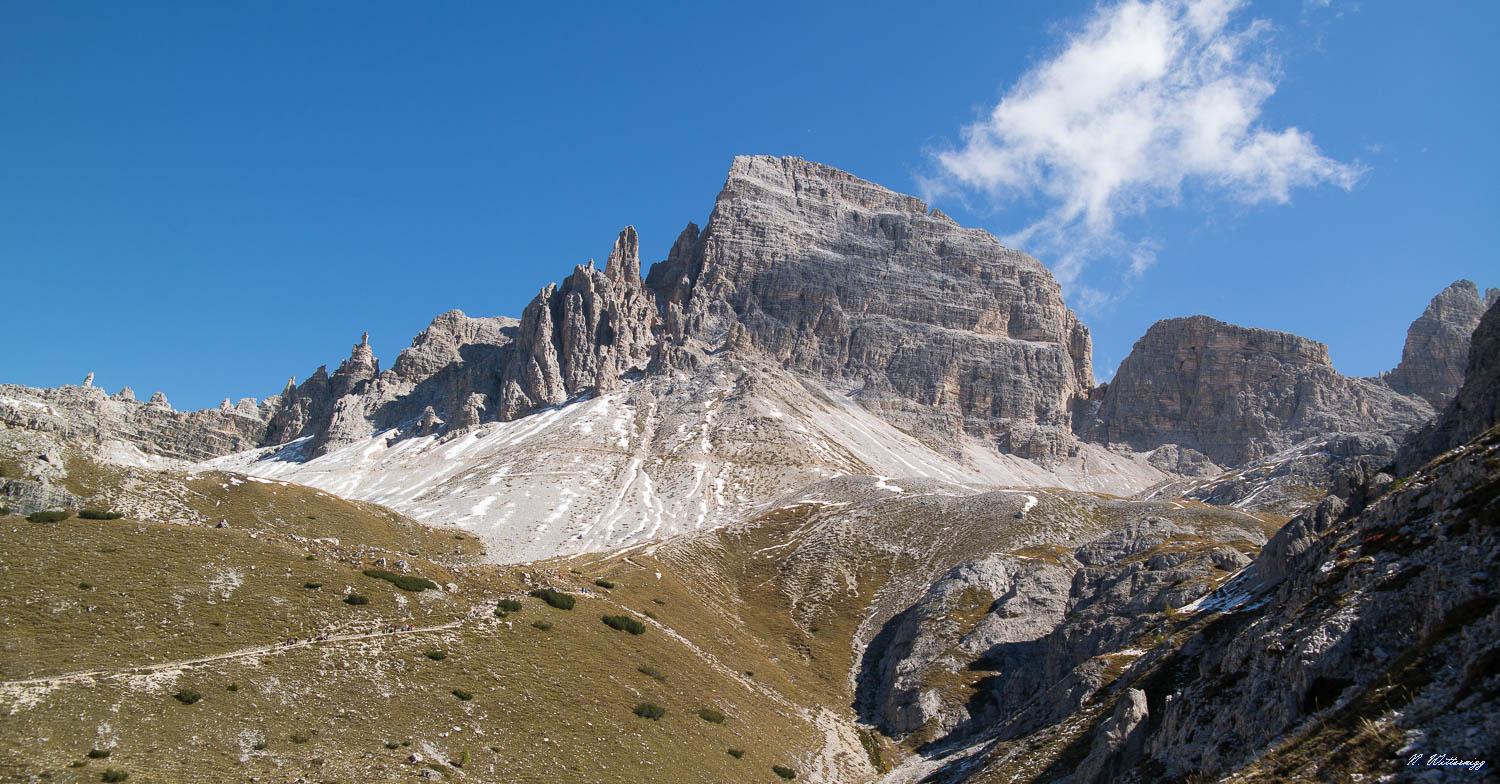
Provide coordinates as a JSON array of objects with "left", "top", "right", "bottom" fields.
[{"left": 0, "top": 0, "right": 1500, "bottom": 408}]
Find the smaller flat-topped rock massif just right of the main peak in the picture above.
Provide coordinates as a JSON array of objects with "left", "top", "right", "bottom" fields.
[{"left": 1080, "top": 316, "right": 1433, "bottom": 465}]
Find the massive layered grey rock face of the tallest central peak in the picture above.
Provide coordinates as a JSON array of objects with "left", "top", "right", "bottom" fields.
[{"left": 648, "top": 157, "right": 1092, "bottom": 457}]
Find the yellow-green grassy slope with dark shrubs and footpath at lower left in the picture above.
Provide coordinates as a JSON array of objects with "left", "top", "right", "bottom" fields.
[{"left": 0, "top": 472, "right": 821, "bottom": 783}]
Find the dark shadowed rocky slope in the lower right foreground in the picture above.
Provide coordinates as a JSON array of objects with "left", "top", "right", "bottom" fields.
[{"left": 888, "top": 296, "right": 1500, "bottom": 783}]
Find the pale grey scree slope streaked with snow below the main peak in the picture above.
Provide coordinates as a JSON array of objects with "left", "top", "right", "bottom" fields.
[{"left": 196, "top": 355, "right": 1166, "bottom": 562}]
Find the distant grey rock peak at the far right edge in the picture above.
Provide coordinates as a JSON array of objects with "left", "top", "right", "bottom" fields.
[{"left": 1386, "top": 280, "right": 1500, "bottom": 411}]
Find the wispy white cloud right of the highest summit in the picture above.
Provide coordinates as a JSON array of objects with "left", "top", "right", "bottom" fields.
[{"left": 926, "top": 0, "right": 1362, "bottom": 304}]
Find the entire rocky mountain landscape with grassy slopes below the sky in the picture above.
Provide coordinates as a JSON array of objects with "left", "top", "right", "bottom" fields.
[{"left": 0, "top": 156, "right": 1500, "bottom": 784}]
